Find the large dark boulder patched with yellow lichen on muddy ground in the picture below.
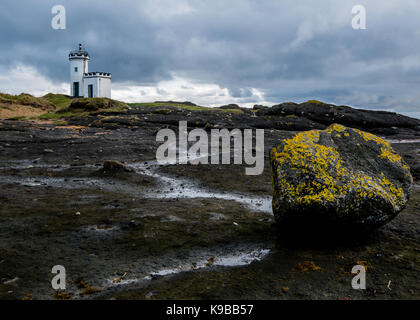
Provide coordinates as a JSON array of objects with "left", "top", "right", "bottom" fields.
[{"left": 270, "top": 124, "right": 413, "bottom": 230}]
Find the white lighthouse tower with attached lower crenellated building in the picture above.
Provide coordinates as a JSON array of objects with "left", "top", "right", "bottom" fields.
[{"left": 69, "top": 44, "right": 111, "bottom": 98}]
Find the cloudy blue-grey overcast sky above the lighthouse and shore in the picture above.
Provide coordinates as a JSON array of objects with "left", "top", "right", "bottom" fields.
[{"left": 0, "top": 0, "right": 420, "bottom": 118}]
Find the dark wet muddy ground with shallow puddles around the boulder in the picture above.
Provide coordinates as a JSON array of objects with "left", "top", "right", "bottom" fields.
[{"left": 0, "top": 109, "right": 420, "bottom": 299}]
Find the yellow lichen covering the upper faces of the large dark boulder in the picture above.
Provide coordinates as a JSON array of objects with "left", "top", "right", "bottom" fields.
[{"left": 270, "top": 124, "right": 411, "bottom": 228}]
